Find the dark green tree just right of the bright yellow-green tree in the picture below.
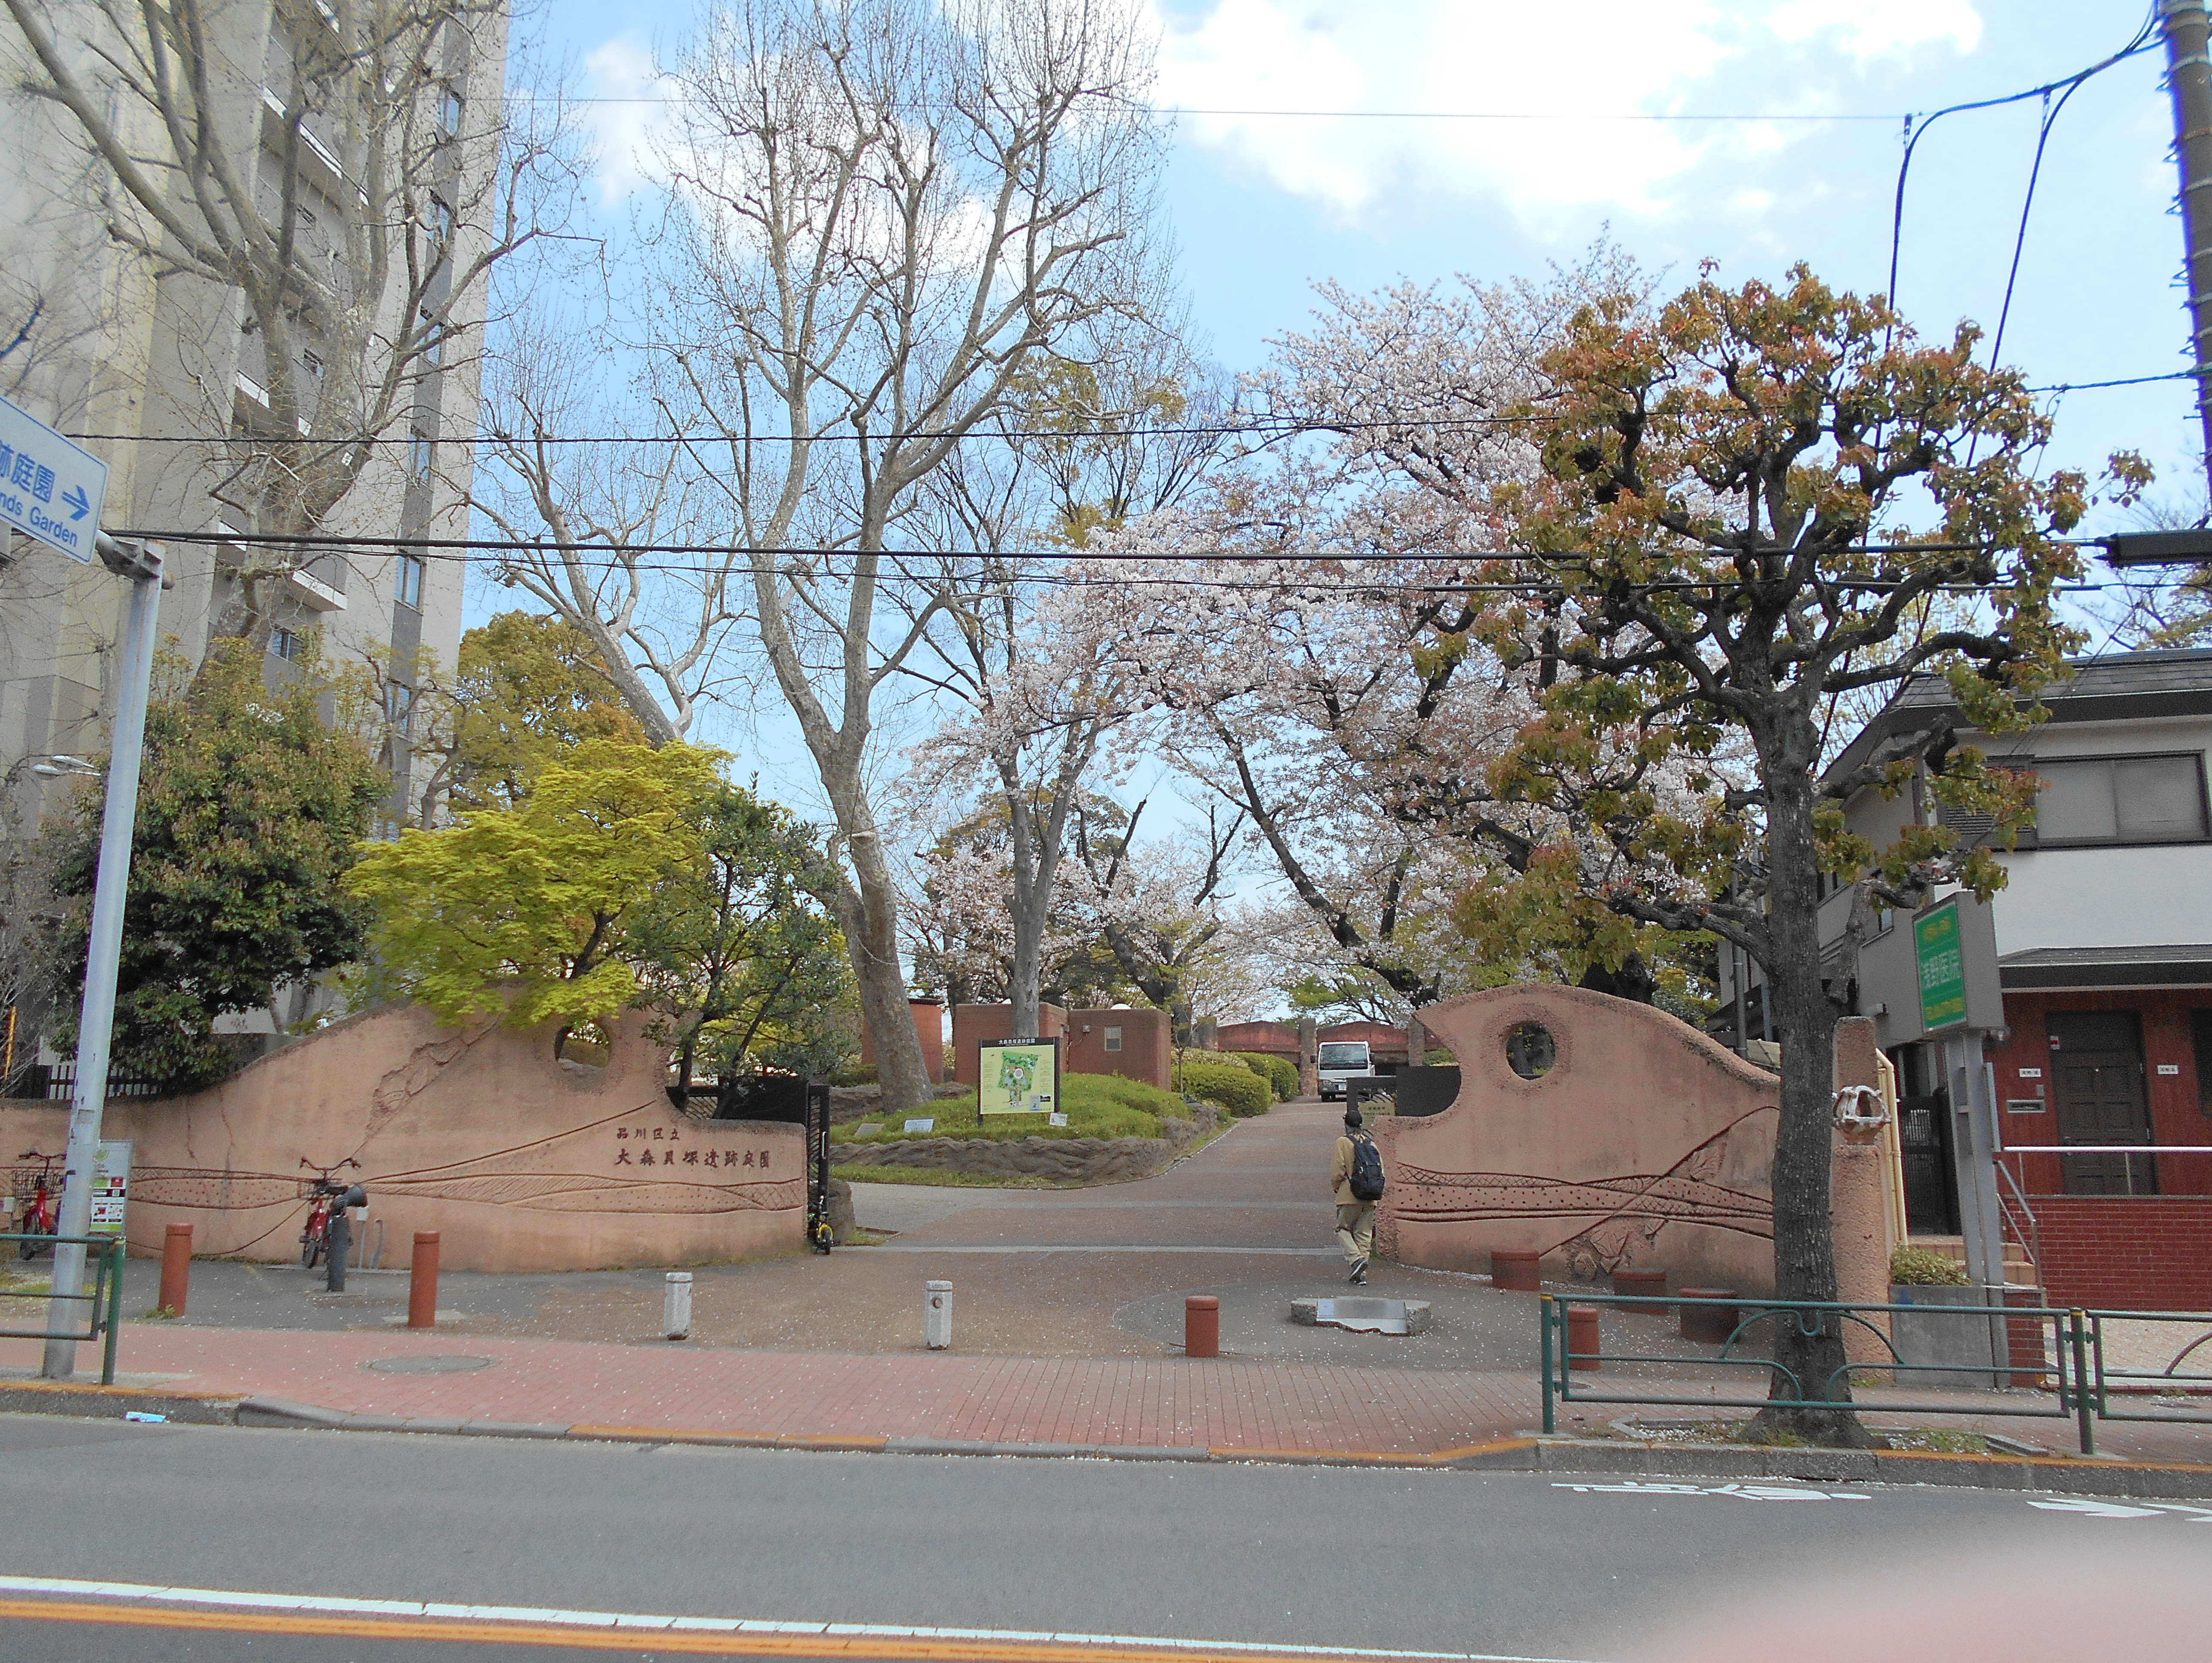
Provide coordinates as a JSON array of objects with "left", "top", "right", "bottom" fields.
[{"left": 626, "top": 785, "right": 856, "bottom": 1086}]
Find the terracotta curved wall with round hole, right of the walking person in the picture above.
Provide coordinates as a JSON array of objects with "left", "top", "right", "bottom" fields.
[{"left": 1376, "top": 986, "right": 1781, "bottom": 1294}]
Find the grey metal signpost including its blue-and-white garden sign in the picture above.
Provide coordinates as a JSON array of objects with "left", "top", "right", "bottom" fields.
[{"left": 0, "top": 398, "right": 161, "bottom": 1380}]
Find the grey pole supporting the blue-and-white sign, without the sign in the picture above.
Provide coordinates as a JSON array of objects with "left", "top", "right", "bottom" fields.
[{"left": 40, "top": 533, "right": 161, "bottom": 1380}]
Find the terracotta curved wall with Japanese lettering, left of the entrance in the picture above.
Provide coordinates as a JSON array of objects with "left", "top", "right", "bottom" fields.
[{"left": 0, "top": 1008, "right": 807, "bottom": 1272}]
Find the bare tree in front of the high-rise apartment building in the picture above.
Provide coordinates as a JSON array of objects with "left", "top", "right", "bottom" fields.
[{"left": 0, "top": 0, "right": 568, "bottom": 630}]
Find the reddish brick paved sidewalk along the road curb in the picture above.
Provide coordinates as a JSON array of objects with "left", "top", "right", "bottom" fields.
[{"left": 0, "top": 1325, "right": 2212, "bottom": 1462}]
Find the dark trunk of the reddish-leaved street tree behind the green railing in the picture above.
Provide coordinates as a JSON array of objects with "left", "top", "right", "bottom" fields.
[{"left": 1754, "top": 723, "right": 1869, "bottom": 1449}]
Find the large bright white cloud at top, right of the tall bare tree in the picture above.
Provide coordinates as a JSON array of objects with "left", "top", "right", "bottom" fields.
[{"left": 1159, "top": 0, "right": 1980, "bottom": 235}]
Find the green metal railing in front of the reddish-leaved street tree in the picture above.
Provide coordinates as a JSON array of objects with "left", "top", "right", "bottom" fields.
[{"left": 1537, "top": 1294, "right": 2114, "bottom": 1455}]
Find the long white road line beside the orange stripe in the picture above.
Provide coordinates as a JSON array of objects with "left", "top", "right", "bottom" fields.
[{"left": 0, "top": 1577, "right": 1586, "bottom": 1663}]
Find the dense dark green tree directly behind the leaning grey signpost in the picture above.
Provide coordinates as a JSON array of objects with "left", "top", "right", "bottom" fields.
[{"left": 56, "top": 639, "right": 389, "bottom": 1088}]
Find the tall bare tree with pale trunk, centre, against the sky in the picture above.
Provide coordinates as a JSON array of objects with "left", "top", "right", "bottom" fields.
[{"left": 584, "top": 0, "right": 1161, "bottom": 1106}]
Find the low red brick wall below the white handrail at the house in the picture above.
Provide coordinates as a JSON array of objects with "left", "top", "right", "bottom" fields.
[{"left": 2035, "top": 1196, "right": 2212, "bottom": 1311}]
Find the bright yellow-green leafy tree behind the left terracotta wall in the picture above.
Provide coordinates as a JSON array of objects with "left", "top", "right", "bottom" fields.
[{"left": 347, "top": 739, "right": 719, "bottom": 1035}]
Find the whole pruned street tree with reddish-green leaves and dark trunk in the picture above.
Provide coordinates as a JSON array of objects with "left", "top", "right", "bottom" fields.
[{"left": 1478, "top": 268, "right": 2146, "bottom": 1442}]
